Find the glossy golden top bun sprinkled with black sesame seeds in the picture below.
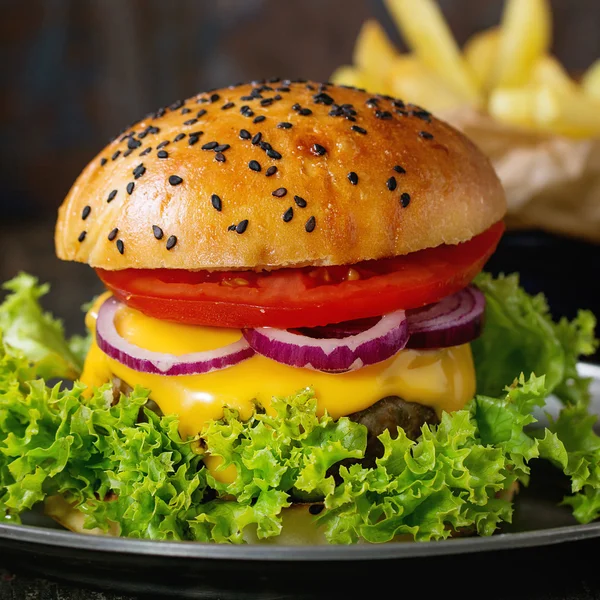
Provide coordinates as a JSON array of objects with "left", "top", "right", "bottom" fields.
[{"left": 55, "top": 79, "right": 506, "bottom": 270}]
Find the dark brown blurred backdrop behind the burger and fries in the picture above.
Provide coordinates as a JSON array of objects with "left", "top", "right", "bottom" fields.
[{"left": 0, "top": 0, "right": 600, "bottom": 356}]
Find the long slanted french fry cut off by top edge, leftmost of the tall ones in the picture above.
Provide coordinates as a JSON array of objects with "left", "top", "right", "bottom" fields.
[{"left": 385, "top": 0, "right": 482, "bottom": 106}]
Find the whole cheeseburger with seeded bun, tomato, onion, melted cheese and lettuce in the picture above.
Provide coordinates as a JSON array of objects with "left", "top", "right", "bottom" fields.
[{"left": 0, "top": 79, "right": 593, "bottom": 543}]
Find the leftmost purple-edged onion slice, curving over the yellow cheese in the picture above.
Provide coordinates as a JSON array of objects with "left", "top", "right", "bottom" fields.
[{"left": 96, "top": 296, "right": 254, "bottom": 375}]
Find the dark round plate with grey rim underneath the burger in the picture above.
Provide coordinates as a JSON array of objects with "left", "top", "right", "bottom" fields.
[{"left": 0, "top": 364, "right": 600, "bottom": 600}]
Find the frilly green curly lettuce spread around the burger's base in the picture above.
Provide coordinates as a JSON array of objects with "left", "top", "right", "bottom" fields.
[{"left": 0, "top": 275, "right": 600, "bottom": 544}]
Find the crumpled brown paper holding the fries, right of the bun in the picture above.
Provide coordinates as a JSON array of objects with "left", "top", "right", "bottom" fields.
[{"left": 438, "top": 109, "right": 600, "bottom": 242}]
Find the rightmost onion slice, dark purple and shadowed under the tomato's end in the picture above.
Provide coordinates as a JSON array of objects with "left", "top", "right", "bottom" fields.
[{"left": 406, "top": 285, "right": 485, "bottom": 349}]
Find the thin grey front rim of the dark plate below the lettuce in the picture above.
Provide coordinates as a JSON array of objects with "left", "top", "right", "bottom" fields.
[{"left": 0, "top": 363, "right": 600, "bottom": 562}]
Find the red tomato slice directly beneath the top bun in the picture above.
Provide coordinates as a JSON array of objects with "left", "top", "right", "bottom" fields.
[{"left": 97, "top": 222, "right": 504, "bottom": 329}]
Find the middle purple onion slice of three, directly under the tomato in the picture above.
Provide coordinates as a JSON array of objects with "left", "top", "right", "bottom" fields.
[{"left": 244, "top": 310, "right": 408, "bottom": 373}]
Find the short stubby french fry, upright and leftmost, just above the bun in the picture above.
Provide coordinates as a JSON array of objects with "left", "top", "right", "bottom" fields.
[{"left": 353, "top": 19, "right": 398, "bottom": 81}]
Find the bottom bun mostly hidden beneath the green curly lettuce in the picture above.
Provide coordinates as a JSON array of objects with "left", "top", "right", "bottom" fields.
[{"left": 44, "top": 482, "right": 519, "bottom": 546}]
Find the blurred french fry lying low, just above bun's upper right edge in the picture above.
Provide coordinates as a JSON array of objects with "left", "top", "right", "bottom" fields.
[{"left": 388, "top": 55, "right": 464, "bottom": 111}]
